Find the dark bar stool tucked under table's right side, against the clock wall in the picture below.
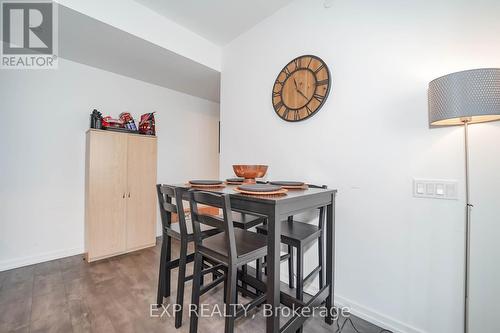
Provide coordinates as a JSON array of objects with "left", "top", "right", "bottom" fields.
[{"left": 256, "top": 185, "right": 327, "bottom": 301}]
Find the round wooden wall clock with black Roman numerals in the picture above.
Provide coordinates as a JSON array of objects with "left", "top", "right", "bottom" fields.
[{"left": 272, "top": 55, "right": 331, "bottom": 121}]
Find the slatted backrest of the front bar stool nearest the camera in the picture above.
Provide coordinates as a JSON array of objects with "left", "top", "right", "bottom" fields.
[{"left": 189, "top": 190, "right": 238, "bottom": 259}]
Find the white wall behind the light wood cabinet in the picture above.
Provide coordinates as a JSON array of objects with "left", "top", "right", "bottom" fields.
[{"left": 0, "top": 59, "right": 219, "bottom": 271}]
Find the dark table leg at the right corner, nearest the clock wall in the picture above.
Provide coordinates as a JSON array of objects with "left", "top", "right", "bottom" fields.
[{"left": 325, "top": 195, "right": 335, "bottom": 325}]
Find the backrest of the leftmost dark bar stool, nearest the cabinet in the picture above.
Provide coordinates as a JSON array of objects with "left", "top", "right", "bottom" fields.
[{"left": 156, "top": 184, "right": 187, "bottom": 237}]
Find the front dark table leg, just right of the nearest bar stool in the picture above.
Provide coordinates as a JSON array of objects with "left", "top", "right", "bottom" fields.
[{"left": 266, "top": 208, "right": 281, "bottom": 333}]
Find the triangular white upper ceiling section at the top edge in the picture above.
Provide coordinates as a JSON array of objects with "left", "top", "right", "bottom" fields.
[{"left": 135, "top": 0, "right": 293, "bottom": 46}]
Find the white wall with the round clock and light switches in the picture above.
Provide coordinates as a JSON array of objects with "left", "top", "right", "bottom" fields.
[{"left": 221, "top": 0, "right": 500, "bottom": 333}]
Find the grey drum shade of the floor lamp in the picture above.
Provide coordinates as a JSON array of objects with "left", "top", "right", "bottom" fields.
[{"left": 429, "top": 68, "right": 500, "bottom": 126}]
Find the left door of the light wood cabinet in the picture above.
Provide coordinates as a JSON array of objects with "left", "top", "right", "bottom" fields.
[{"left": 85, "top": 131, "right": 127, "bottom": 261}]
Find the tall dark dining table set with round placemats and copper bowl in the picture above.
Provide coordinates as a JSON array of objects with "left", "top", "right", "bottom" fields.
[{"left": 171, "top": 184, "right": 337, "bottom": 333}]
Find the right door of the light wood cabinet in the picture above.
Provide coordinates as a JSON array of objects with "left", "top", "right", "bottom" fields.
[{"left": 127, "top": 135, "right": 158, "bottom": 250}]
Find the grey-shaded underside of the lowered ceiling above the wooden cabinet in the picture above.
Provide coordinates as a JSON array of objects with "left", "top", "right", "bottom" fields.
[{"left": 58, "top": 6, "right": 220, "bottom": 102}]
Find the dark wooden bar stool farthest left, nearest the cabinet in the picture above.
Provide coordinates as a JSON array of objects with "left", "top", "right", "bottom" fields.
[{"left": 156, "top": 184, "right": 224, "bottom": 328}]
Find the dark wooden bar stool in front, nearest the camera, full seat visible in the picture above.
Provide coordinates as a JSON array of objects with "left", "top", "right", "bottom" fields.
[{"left": 189, "top": 190, "right": 267, "bottom": 333}]
